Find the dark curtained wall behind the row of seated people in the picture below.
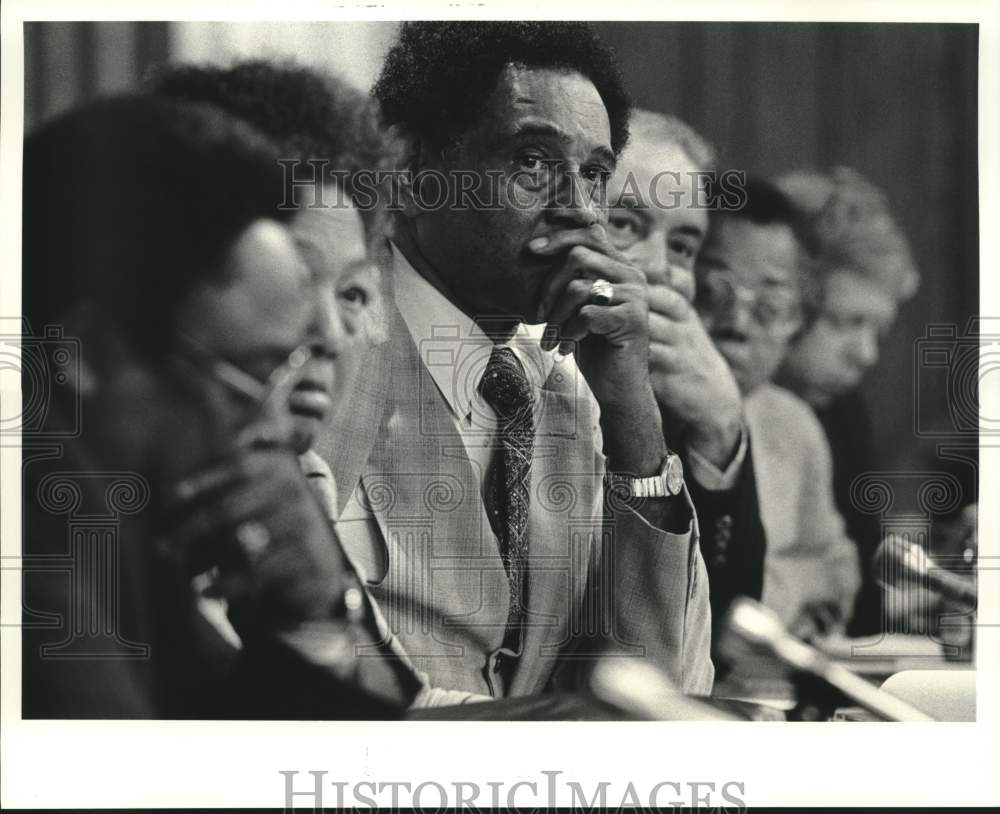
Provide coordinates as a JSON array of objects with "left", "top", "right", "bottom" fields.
[{"left": 25, "top": 22, "right": 979, "bottom": 484}]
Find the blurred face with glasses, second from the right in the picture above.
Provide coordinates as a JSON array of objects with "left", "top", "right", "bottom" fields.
[{"left": 695, "top": 215, "right": 800, "bottom": 395}]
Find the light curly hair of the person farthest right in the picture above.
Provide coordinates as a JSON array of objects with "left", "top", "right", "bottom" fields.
[{"left": 777, "top": 167, "right": 920, "bottom": 300}]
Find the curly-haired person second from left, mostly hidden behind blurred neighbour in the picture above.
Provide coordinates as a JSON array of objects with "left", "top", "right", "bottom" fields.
[{"left": 154, "top": 61, "right": 473, "bottom": 707}]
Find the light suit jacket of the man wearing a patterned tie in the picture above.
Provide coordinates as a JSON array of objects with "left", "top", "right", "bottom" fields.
[{"left": 315, "top": 302, "right": 714, "bottom": 697}]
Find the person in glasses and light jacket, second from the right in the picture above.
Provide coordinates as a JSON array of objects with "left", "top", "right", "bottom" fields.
[{"left": 695, "top": 180, "right": 860, "bottom": 637}]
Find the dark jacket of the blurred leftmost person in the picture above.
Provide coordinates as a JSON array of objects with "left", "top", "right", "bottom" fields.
[{"left": 22, "top": 404, "right": 417, "bottom": 719}]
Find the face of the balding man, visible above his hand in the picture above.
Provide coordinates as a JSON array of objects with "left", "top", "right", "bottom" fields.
[{"left": 608, "top": 136, "right": 708, "bottom": 302}]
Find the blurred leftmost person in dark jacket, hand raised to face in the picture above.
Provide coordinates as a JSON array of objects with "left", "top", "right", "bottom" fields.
[{"left": 22, "top": 97, "right": 416, "bottom": 718}]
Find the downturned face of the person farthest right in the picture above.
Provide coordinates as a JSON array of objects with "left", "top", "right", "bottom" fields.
[{"left": 785, "top": 271, "right": 896, "bottom": 406}]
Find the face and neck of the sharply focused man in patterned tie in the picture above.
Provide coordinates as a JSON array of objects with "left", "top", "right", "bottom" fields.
[{"left": 404, "top": 66, "right": 615, "bottom": 322}]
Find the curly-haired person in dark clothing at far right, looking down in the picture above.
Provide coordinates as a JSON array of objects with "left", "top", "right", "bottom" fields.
[{"left": 776, "top": 167, "right": 918, "bottom": 636}]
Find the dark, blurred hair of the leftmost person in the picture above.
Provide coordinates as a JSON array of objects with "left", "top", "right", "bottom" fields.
[{"left": 22, "top": 95, "right": 291, "bottom": 355}]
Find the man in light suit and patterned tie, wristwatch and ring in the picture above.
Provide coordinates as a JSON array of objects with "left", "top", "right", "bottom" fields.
[{"left": 317, "top": 22, "right": 713, "bottom": 698}]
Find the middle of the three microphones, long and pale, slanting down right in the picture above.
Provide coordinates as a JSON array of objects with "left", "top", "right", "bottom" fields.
[{"left": 719, "top": 596, "right": 934, "bottom": 721}]
